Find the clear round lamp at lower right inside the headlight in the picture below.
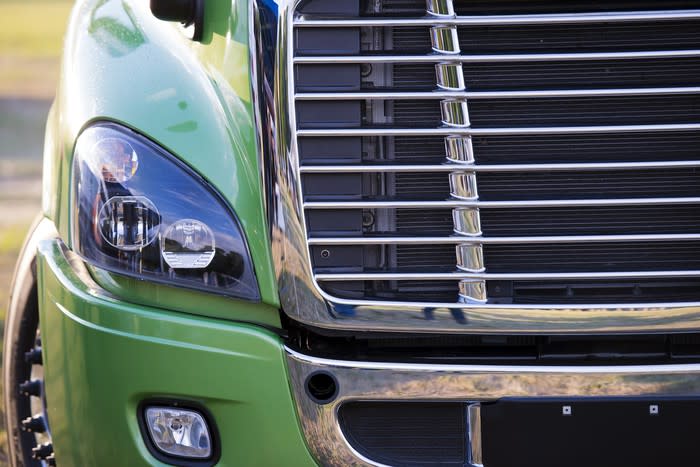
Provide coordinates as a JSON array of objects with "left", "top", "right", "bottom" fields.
[{"left": 161, "top": 219, "right": 216, "bottom": 269}]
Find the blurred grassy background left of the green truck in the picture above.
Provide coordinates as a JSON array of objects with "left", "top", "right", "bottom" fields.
[{"left": 0, "top": 0, "right": 73, "bottom": 465}]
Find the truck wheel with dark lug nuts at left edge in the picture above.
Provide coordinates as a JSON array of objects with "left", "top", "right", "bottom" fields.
[{"left": 3, "top": 247, "right": 56, "bottom": 467}]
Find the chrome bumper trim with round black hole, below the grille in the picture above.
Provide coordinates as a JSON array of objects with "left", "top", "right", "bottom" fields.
[{"left": 285, "top": 347, "right": 700, "bottom": 466}]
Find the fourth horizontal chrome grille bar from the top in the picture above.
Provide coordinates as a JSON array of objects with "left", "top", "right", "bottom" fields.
[{"left": 297, "top": 123, "right": 700, "bottom": 136}]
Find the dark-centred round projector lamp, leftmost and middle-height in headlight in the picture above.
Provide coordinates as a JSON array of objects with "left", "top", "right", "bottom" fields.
[{"left": 97, "top": 196, "right": 160, "bottom": 251}]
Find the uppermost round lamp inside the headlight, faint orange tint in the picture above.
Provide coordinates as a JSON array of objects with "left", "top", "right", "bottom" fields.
[{"left": 91, "top": 138, "right": 139, "bottom": 183}]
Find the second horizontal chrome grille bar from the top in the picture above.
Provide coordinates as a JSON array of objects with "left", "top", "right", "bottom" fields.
[{"left": 293, "top": 49, "right": 700, "bottom": 64}]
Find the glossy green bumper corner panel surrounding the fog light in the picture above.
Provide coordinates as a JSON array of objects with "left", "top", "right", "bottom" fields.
[{"left": 37, "top": 240, "right": 315, "bottom": 466}]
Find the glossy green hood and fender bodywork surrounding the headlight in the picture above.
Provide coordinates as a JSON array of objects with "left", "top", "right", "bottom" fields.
[{"left": 44, "top": 0, "right": 279, "bottom": 316}]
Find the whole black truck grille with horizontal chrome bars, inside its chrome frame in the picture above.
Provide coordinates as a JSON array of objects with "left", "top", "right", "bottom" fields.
[{"left": 290, "top": 0, "right": 700, "bottom": 305}]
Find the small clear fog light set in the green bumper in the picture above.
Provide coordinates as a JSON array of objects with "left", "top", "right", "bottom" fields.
[{"left": 146, "top": 407, "right": 212, "bottom": 459}]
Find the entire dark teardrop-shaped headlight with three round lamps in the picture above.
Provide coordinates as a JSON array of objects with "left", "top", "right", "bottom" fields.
[{"left": 72, "top": 124, "right": 260, "bottom": 300}]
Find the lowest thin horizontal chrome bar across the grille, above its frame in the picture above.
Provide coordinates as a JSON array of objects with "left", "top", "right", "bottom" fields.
[{"left": 314, "top": 270, "right": 700, "bottom": 282}]
